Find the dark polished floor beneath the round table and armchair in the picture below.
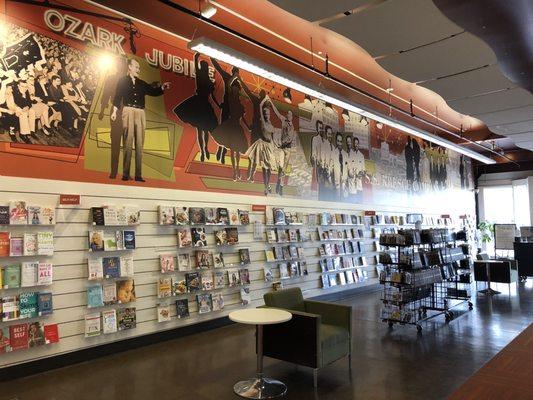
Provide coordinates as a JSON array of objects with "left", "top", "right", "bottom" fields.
[{"left": 0, "top": 279, "right": 533, "bottom": 400}]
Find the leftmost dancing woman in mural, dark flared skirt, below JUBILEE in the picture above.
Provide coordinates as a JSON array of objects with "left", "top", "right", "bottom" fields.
[{"left": 173, "top": 53, "right": 221, "bottom": 162}]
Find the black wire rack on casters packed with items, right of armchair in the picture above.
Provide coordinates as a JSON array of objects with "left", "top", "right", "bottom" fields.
[{"left": 379, "top": 229, "right": 473, "bottom": 332}]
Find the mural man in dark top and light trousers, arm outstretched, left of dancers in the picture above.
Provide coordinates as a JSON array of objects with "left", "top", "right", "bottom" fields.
[{"left": 111, "top": 59, "right": 170, "bottom": 182}]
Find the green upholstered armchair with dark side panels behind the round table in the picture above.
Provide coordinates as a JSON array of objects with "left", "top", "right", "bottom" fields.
[{"left": 263, "top": 288, "right": 352, "bottom": 387}]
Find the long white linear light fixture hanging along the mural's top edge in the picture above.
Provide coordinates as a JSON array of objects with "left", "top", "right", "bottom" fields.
[{"left": 188, "top": 37, "right": 496, "bottom": 164}]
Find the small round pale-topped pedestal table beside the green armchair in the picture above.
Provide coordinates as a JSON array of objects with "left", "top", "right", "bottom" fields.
[{"left": 228, "top": 308, "right": 292, "bottom": 399}]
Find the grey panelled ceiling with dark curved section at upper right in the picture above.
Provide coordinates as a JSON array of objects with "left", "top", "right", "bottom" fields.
[{"left": 269, "top": 0, "right": 533, "bottom": 162}]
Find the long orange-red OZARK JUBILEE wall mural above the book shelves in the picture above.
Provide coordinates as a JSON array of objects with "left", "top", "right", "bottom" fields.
[{"left": 0, "top": 4, "right": 473, "bottom": 205}]
